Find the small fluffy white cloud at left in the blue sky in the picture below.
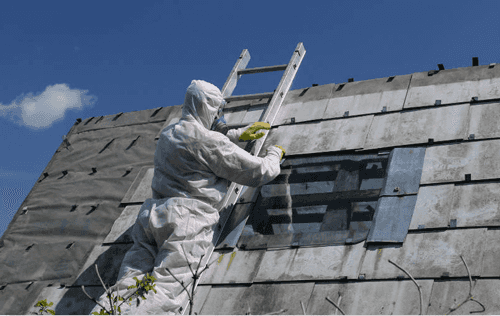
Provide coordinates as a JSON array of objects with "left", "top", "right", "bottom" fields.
[{"left": 0, "top": 83, "right": 97, "bottom": 129}]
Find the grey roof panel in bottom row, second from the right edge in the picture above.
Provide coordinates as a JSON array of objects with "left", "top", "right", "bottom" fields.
[{"left": 306, "top": 280, "right": 434, "bottom": 315}]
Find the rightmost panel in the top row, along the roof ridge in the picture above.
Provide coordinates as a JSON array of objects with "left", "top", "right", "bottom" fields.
[{"left": 404, "top": 65, "right": 500, "bottom": 108}]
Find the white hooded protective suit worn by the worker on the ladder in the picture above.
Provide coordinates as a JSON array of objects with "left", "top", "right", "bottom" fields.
[{"left": 93, "top": 80, "right": 281, "bottom": 314}]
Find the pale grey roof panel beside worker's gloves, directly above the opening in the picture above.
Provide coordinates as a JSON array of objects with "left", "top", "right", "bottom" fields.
[{"left": 259, "top": 115, "right": 373, "bottom": 157}]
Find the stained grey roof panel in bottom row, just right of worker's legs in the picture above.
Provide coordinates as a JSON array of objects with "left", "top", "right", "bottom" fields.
[{"left": 201, "top": 282, "right": 314, "bottom": 315}]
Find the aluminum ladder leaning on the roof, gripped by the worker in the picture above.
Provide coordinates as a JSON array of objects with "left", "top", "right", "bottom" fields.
[{"left": 182, "top": 43, "right": 306, "bottom": 314}]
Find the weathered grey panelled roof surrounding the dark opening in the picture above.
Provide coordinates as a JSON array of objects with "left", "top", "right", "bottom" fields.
[{"left": 0, "top": 65, "right": 500, "bottom": 314}]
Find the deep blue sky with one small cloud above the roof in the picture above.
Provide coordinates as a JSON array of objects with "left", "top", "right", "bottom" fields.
[{"left": 0, "top": 0, "right": 500, "bottom": 235}]
